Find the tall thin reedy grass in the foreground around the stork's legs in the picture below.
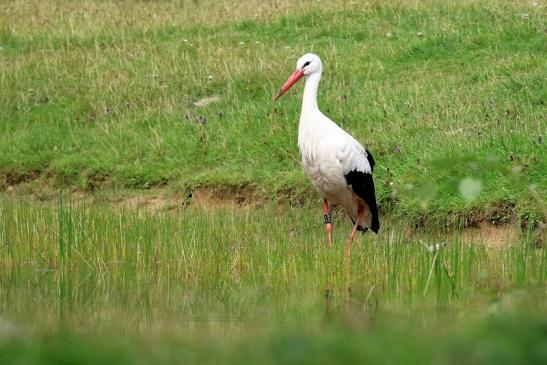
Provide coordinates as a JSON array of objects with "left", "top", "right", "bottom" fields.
[{"left": 0, "top": 196, "right": 547, "bottom": 363}]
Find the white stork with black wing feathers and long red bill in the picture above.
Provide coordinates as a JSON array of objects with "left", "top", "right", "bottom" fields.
[{"left": 274, "top": 53, "right": 380, "bottom": 256}]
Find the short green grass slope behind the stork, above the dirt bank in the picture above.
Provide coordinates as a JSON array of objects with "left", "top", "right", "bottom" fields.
[{"left": 0, "top": 1, "right": 547, "bottom": 222}]
